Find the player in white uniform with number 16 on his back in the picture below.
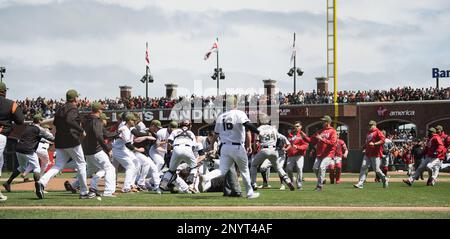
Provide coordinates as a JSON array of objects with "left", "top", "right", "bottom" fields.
[{"left": 200, "top": 96, "right": 259, "bottom": 199}]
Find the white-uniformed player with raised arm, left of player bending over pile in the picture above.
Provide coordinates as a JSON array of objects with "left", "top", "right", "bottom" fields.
[{"left": 149, "top": 121, "right": 178, "bottom": 171}]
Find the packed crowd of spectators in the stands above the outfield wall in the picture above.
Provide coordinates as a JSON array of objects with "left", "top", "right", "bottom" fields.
[{"left": 14, "top": 87, "right": 450, "bottom": 119}]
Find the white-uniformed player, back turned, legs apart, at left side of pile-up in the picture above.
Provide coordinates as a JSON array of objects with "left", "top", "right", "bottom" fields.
[{"left": 159, "top": 120, "right": 197, "bottom": 192}]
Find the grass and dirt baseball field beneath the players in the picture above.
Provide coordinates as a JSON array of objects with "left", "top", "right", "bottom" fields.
[{"left": 0, "top": 173, "right": 450, "bottom": 219}]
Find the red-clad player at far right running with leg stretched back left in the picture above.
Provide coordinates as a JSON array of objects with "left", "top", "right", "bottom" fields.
[{"left": 403, "top": 128, "right": 446, "bottom": 186}]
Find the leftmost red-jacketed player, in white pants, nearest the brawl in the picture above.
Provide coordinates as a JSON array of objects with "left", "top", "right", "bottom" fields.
[{"left": 286, "top": 121, "right": 310, "bottom": 190}]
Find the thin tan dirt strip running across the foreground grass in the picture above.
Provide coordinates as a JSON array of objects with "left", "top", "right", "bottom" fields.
[{"left": 0, "top": 206, "right": 450, "bottom": 212}]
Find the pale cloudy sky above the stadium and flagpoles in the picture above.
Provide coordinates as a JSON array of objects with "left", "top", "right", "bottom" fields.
[{"left": 0, "top": 0, "right": 450, "bottom": 99}]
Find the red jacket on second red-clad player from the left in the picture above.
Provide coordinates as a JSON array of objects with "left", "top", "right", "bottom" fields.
[{"left": 311, "top": 126, "right": 337, "bottom": 159}]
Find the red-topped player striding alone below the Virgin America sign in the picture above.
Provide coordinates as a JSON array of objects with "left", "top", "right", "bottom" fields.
[{"left": 353, "top": 120, "right": 388, "bottom": 189}]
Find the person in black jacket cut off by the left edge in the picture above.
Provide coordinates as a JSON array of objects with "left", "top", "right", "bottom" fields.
[{"left": 0, "top": 82, "right": 25, "bottom": 202}]
